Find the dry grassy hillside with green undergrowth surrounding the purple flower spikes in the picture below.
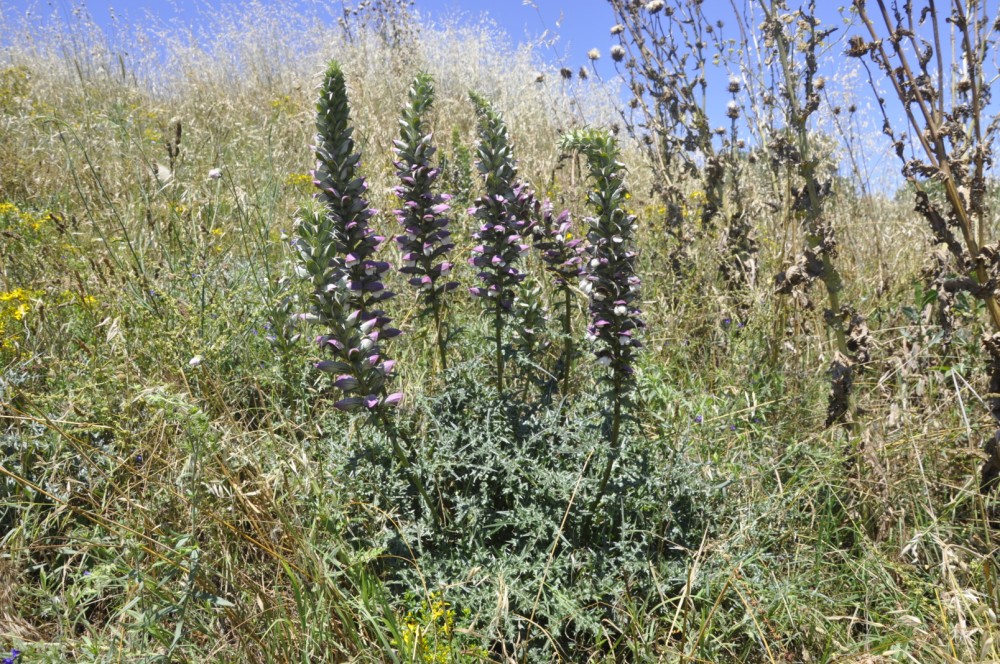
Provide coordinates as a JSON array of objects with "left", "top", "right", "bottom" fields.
[{"left": 0, "top": 0, "right": 1000, "bottom": 662}]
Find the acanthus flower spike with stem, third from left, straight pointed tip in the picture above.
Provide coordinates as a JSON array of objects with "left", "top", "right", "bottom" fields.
[{"left": 469, "top": 93, "right": 535, "bottom": 392}]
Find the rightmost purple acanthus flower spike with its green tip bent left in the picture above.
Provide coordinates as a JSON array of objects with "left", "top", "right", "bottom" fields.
[{"left": 561, "top": 129, "right": 645, "bottom": 505}]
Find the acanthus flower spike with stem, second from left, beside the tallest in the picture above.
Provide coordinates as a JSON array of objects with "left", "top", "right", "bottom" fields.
[{"left": 394, "top": 74, "right": 458, "bottom": 369}]
